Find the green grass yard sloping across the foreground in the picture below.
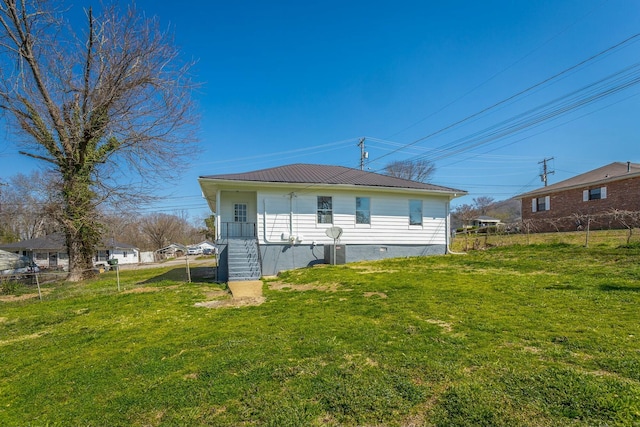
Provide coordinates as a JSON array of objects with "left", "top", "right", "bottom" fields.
[{"left": 0, "top": 243, "right": 640, "bottom": 427}]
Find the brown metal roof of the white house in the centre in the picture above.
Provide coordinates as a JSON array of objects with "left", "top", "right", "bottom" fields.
[{"left": 200, "top": 163, "right": 466, "bottom": 193}]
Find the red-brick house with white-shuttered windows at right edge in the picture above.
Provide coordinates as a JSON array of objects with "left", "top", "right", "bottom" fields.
[{"left": 515, "top": 162, "right": 640, "bottom": 232}]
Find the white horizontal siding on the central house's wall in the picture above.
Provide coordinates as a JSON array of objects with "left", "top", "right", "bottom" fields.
[{"left": 258, "top": 190, "right": 448, "bottom": 245}]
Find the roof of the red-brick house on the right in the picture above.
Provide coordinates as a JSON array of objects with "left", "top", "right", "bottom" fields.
[{"left": 515, "top": 162, "right": 640, "bottom": 199}]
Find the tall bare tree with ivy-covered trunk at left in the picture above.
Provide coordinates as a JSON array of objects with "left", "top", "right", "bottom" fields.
[{"left": 0, "top": 0, "right": 196, "bottom": 280}]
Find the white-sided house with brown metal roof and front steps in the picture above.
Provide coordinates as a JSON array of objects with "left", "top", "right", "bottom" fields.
[{"left": 198, "top": 164, "right": 466, "bottom": 280}]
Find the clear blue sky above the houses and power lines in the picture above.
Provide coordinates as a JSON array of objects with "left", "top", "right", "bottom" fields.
[{"left": 0, "top": 0, "right": 640, "bottom": 221}]
